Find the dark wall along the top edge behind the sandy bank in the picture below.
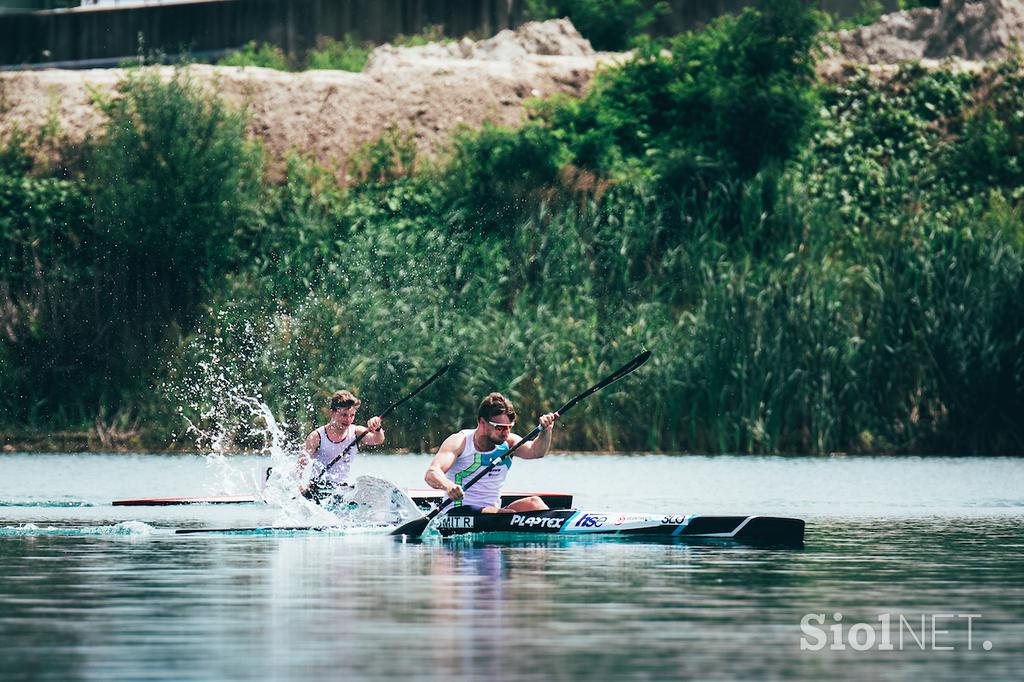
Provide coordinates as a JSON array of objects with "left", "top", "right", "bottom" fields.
[{"left": 0, "top": 0, "right": 898, "bottom": 67}]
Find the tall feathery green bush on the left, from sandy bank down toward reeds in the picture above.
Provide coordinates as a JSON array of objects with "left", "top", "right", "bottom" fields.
[{"left": 79, "top": 70, "right": 262, "bottom": 417}]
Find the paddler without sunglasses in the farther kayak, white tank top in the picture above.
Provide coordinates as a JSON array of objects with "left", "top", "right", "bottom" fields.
[{"left": 299, "top": 390, "right": 384, "bottom": 494}]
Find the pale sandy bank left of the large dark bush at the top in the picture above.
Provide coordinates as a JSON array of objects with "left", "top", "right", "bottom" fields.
[{"left": 0, "top": 19, "right": 618, "bottom": 180}]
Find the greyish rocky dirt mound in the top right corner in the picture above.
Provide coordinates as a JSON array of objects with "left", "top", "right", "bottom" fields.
[{"left": 834, "top": 0, "right": 1024, "bottom": 63}]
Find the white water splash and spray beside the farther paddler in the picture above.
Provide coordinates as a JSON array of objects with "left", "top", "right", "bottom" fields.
[{"left": 166, "top": 311, "right": 419, "bottom": 529}]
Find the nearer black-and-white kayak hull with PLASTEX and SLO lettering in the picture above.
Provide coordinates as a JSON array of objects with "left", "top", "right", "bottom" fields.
[{"left": 436, "top": 509, "right": 804, "bottom": 546}]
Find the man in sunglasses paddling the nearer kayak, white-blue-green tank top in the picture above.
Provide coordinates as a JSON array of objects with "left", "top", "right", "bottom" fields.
[{"left": 424, "top": 393, "right": 558, "bottom": 513}]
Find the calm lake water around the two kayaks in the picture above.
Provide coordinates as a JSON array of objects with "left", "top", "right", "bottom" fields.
[{"left": 0, "top": 454, "right": 1024, "bottom": 682}]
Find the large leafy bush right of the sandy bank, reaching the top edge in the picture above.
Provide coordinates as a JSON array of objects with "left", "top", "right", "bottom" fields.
[{"left": 540, "top": 0, "right": 817, "bottom": 177}]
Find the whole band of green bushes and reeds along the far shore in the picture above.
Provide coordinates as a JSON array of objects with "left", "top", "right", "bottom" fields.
[{"left": 0, "top": 0, "right": 1024, "bottom": 454}]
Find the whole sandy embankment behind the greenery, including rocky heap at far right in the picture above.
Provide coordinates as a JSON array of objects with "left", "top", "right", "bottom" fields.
[{"left": 0, "top": 0, "right": 1024, "bottom": 176}]
